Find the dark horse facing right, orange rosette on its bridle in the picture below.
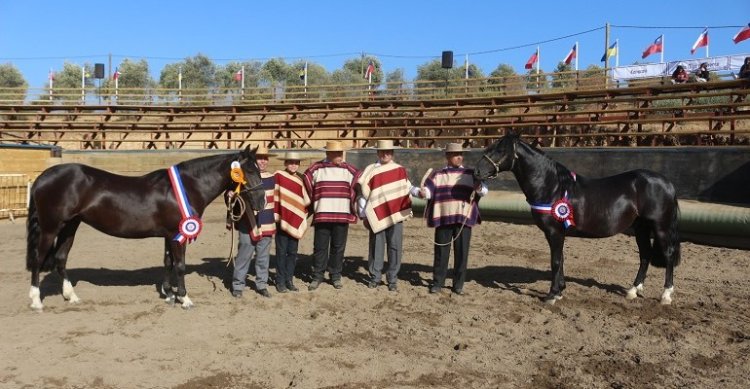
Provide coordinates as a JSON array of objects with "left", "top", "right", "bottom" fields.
[{"left": 26, "top": 146, "right": 265, "bottom": 310}]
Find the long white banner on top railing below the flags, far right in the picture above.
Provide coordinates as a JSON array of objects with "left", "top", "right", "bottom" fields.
[{"left": 612, "top": 54, "right": 750, "bottom": 80}]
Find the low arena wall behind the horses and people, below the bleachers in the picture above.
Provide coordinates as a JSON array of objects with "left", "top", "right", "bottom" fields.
[{"left": 0, "top": 147, "right": 750, "bottom": 204}]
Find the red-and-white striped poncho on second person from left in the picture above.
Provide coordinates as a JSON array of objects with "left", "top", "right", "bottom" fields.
[{"left": 273, "top": 170, "right": 310, "bottom": 239}]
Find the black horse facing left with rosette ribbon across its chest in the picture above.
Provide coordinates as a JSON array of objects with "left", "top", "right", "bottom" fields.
[{"left": 474, "top": 134, "right": 680, "bottom": 304}]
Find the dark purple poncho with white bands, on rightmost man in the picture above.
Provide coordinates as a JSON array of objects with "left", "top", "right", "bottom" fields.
[{"left": 425, "top": 167, "right": 481, "bottom": 227}]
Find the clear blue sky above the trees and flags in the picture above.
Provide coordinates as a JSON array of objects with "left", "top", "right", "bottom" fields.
[{"left": 0, "top": 0, "right": 750, "bottom": 88}]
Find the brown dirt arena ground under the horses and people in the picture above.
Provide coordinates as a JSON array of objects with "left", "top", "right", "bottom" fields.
[{"left": 0, "top": 199, "right": 750, "bottom": 388}]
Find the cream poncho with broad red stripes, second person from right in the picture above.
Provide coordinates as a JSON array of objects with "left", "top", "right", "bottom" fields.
[{"left": 358, "top": 162, "right": 412, "bottom": 233}]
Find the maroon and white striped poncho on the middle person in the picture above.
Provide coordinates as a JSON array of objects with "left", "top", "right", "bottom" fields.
[{"left": 304, "top": 160, "right": 359, "bottom": 224}]
